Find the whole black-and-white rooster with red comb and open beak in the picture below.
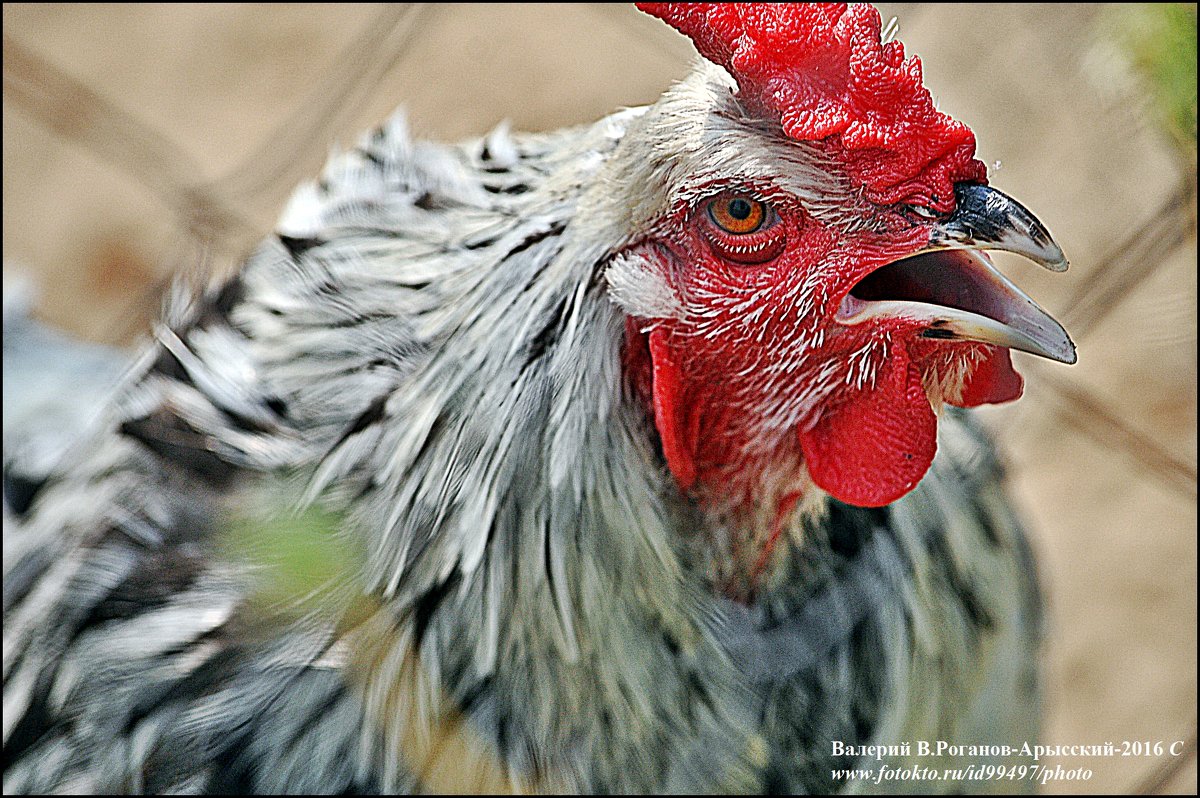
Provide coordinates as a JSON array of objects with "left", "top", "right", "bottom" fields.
[{"left": 4, "top": 4, "right": 1075, "bottom": 793}]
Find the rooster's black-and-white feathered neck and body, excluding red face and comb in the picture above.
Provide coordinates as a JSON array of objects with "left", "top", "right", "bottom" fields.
[{"left": 4, "top": 4, "right": 1070, "bottom": 792}]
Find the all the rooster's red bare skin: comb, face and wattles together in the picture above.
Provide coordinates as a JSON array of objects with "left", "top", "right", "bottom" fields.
[{"left": 626, "top": 2, "right": 1021, "bottom": 584}]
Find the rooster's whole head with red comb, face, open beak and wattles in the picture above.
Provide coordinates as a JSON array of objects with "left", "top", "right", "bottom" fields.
[{"left": 607, "top": 4, "right": 1075, "bottom": 506}]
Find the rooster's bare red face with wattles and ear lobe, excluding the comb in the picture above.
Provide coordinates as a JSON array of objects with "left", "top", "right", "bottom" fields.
[{"left": 628, "top": 189, "right": 1021, "bottom": 506}]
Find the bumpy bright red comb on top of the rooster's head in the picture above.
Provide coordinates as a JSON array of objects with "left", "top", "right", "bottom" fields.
[{"left": 637, "top": 2, "right": 988, "bottom": 211}]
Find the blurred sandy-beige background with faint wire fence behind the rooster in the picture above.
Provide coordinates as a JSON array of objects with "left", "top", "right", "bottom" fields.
[{"left": 4, "top": 4, "right": 1196, "bottom": 794}]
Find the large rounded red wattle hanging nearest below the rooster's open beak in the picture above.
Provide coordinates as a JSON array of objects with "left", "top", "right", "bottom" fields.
[{"left": 800, "top": 350, "right": 937, "bottom": 508}]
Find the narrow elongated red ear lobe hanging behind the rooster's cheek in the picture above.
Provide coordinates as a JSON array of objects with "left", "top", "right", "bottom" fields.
[{"left": 648, "top": 328, "right": 700, "bottom": 491}]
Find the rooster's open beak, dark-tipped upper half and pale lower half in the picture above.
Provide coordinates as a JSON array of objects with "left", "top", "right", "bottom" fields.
[{"left": 838, "top": 184, "right": 1076, "bottom": 364}]
